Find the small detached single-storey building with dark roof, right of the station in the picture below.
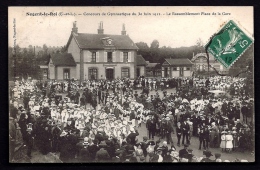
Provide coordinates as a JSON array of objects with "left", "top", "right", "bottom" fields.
[{"left": 161, "top": 58, "right": 192, "bottom": 78}]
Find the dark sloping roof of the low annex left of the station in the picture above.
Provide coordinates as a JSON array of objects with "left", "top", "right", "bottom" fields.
[{"left": 51, "top": 53, "right": 76, "bottom": 66}]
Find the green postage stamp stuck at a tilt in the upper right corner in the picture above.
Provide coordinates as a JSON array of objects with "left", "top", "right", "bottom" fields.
[{"left": 205, "top": 20, "right": 253, "bottom": 68}]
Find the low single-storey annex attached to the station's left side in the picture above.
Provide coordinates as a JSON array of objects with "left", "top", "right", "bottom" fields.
[{"left": 48, "top": 53, "right": 76, "bottom": 80}]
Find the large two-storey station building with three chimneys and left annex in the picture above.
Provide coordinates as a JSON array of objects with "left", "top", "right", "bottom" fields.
[{"left": 49, "top": 22, "right": 139, "bottom": 81}]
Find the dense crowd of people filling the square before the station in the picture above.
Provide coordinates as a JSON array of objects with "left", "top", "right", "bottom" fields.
[{"left": 9, "top": 76, "right": 254, "bottom": 162}]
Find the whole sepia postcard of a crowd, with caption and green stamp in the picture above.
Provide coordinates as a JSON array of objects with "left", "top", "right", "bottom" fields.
[{"left": 8, "top": 6, "right": 255, "bottom": 164}]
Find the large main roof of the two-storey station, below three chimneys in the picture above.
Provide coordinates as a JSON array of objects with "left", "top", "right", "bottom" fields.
[{"left": 67, "top": 33, "right": 138, "bottom": 50}]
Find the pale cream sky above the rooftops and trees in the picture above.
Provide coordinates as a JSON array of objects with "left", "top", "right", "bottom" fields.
[{"left": 8, "top": 7, "right": 254, "bottom": 48}]
